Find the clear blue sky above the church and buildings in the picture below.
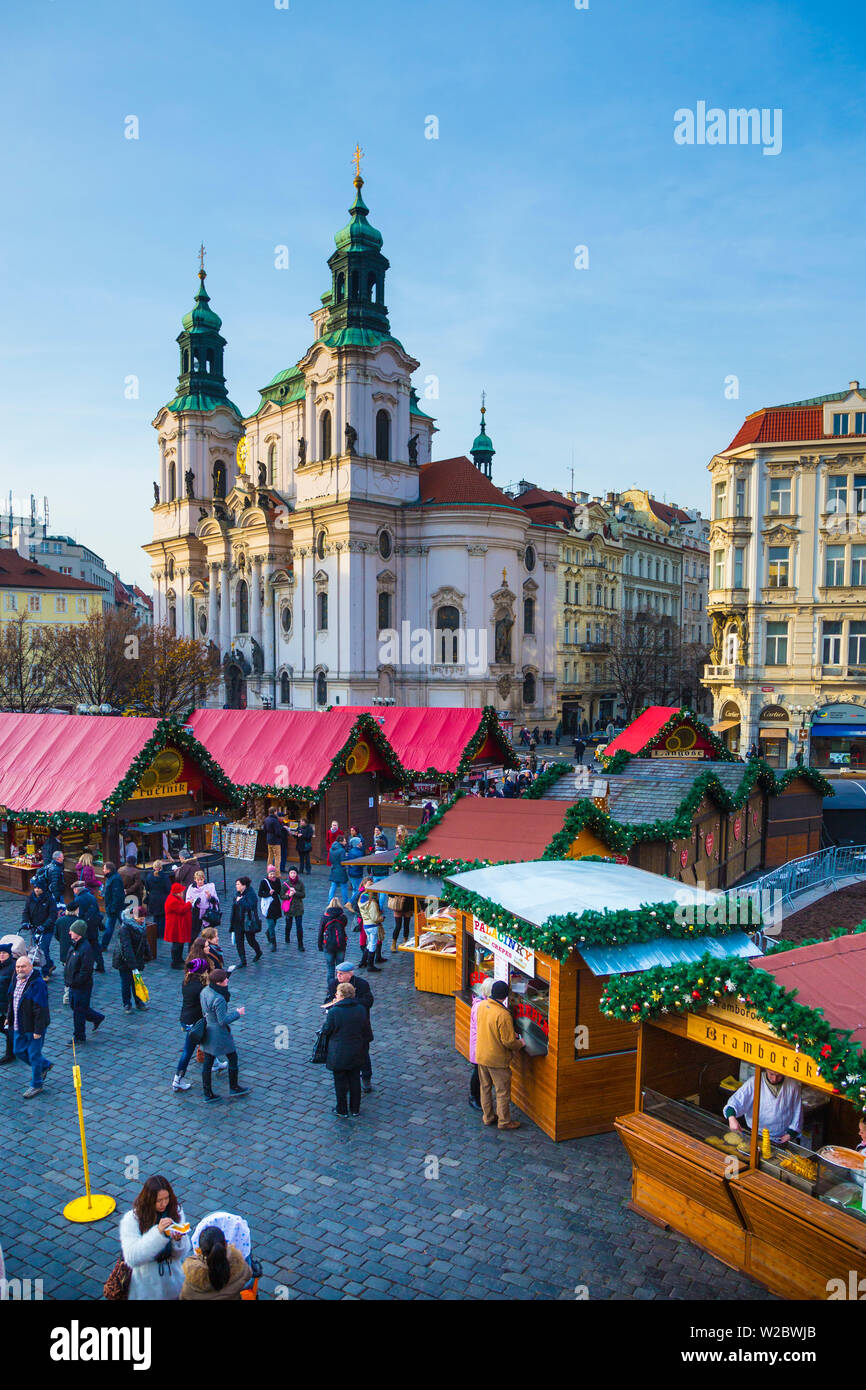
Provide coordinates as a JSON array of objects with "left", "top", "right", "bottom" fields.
[{"left": 0, "top": 0, "right": 866, "bottom": 588}]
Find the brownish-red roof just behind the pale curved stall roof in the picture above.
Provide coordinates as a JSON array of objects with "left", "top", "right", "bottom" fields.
[{"left": 410, "top": 796, "right": 571, "bottom": 863}]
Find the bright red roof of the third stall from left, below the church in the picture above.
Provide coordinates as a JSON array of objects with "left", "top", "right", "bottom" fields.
[{"left": 341, "top": 705, "right": 517, "bottom": 777}]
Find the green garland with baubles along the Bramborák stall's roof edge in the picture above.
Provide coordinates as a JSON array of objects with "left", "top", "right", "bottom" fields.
[{"left": 599, "top": 955, "right": 866, "bottom": 1109}]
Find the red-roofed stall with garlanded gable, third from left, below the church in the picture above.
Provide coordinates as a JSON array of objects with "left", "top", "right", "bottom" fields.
[{"left": 349, "top": 705, "right": 518, "bottom": 830}]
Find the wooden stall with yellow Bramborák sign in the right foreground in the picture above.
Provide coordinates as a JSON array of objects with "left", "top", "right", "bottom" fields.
[{"left": 602, "top": 934, "right": 866, "bottom": 1300}]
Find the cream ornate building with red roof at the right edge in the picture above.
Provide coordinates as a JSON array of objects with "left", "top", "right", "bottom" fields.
[{"left": 705, "top": 381, "right": 866, "bottom": 767}]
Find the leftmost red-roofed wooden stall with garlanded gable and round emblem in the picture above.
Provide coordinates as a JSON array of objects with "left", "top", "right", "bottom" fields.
[{"left": 0, "top": 714, "right": 239, "bottom": 892}]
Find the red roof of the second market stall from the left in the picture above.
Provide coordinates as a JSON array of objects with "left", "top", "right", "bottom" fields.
[{"left": 189, "top": 706, "right": 397, "bottom": 794}]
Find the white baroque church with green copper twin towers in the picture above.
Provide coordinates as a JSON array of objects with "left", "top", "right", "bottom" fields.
[{"left": 145, "top": 174, "right": 559, "bottom": 723}]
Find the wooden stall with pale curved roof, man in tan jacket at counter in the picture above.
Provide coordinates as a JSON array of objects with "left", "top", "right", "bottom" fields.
[{"left": 445, "top": 858, "right": 758, "bottom": 1140}]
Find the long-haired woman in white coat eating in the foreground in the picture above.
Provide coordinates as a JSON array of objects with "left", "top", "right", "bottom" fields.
[{"left": 121, "top": 1173, "right": 192, "bottom": 1302}]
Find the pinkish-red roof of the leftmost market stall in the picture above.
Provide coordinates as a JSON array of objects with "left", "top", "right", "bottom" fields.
[{"left": 0, "top": 714, "right": 158, "bottom": 816}]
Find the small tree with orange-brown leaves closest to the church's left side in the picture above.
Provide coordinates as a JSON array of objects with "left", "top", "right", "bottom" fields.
[{"left": 129, "top": 627, "right": 220, "bottom": 719}]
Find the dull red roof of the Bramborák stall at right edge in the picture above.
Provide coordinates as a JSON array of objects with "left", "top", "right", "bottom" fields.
[{"left": 752, "top": 934, "right": 866, "bottom": 1045}]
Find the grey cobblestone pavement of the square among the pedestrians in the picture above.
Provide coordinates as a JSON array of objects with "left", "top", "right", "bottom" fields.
[{"left": 0, "top": 865, "right": 769, "bottom": 1300}]
